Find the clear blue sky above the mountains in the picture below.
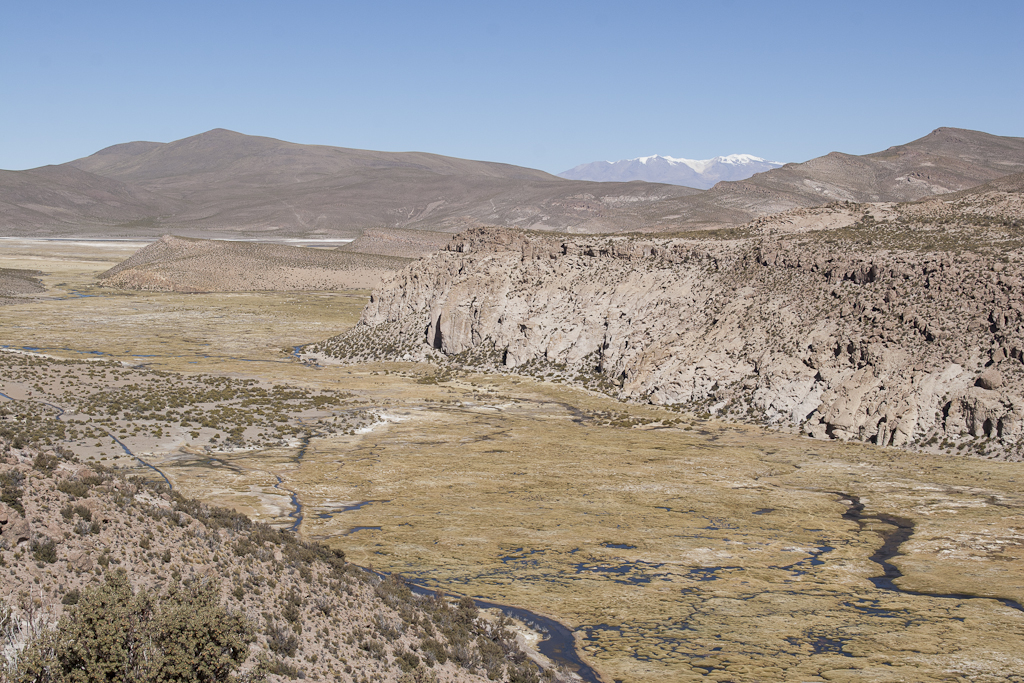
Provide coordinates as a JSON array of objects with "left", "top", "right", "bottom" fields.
[{"left": 0, "top": 0, "right": 1024, "bottom": 172}]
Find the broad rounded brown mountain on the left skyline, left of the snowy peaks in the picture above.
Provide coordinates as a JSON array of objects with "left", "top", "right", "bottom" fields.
[{"left": 0, "top": 129, "right": 699, "bottom": 238}]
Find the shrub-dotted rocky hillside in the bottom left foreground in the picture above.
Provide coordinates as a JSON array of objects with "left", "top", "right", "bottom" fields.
[{"left": 0, "top": 436, "right": 555, "bottom": 683}]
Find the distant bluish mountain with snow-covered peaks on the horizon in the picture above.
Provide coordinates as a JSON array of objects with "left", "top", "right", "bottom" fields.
[{"left": 558, "top": 155, "right": 782, "bottom": 189}]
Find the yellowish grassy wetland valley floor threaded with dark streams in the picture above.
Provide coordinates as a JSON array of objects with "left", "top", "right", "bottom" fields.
[{"left": 0, "top": 241, "right": 1024, "bottom": 683}]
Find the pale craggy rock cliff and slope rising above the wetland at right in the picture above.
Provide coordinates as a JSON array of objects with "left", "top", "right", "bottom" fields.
[{"left": 307, "top": 176, "right": 1024, "bottom": 460}]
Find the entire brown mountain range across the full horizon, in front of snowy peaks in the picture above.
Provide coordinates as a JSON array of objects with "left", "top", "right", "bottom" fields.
[{"left": 0, "top": 128, "right": 1024, "bottom": 238}]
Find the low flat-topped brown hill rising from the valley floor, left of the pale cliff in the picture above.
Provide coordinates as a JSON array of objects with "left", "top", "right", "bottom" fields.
[{"left": 98, "top": 236, "right": 409, "bottom": 292}]
